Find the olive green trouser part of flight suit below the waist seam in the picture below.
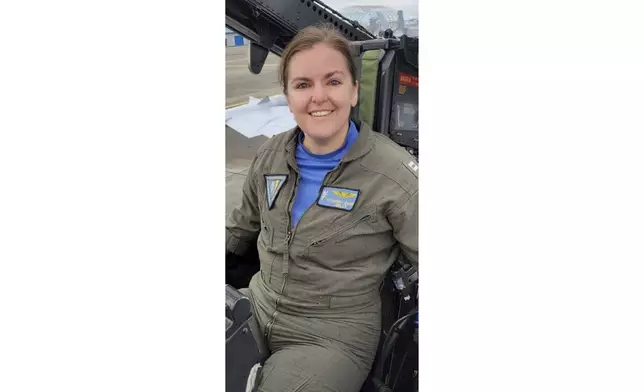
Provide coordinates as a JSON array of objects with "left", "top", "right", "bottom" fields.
[{"left": 248, "top": 275, "right": 381, "bottom": 392}]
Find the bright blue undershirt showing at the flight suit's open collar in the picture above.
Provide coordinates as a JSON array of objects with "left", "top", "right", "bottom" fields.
[{"left": 291, "top": 121, "right": 358, "bottom": 227}]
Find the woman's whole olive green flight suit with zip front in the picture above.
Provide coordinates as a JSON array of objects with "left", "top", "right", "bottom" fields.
[{"left": 226, "top": 123, "right": 418, "bottom": 392}]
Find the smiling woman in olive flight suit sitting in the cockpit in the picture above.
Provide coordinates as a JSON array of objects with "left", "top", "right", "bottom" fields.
[{"left": 226, "top": 27, "right": 418, "bottom": 392}]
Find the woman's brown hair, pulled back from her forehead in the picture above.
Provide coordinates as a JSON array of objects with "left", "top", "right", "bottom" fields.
[{"left": 278, "top": 25, "right": 357, "bottom": 94}]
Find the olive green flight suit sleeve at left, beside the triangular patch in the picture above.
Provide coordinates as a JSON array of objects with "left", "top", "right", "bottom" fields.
[{"left": 226, "top": 156, "right": 261, "bottom": 256}]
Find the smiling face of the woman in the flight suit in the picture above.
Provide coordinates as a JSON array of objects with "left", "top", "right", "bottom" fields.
[{"left": 286, "top": 44, "right": 358, "bottom": 144}]
